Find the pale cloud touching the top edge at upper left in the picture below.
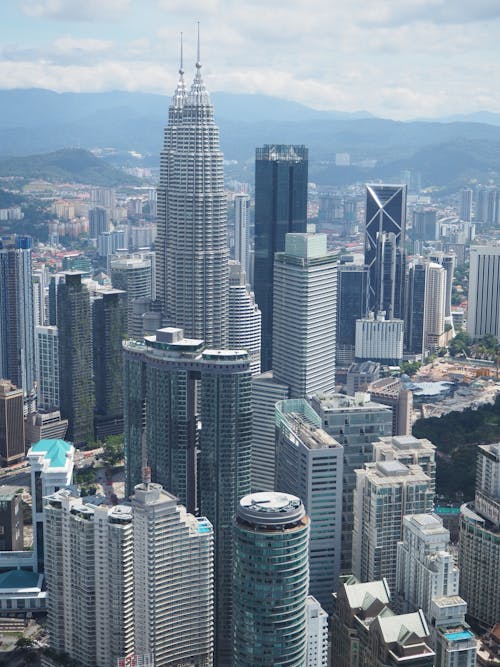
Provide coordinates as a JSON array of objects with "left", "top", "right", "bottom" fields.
[{"left": 21, "top": 0, "right": 131, "bottom": 21}]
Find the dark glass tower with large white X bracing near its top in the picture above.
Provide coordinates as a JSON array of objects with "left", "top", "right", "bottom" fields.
[{"left": 365, "top": 184, "right": 407, "bottom": 319}]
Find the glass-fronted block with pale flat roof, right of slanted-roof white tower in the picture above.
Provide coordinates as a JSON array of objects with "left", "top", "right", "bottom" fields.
[{"left": 311, "top": 393, "right": 392, "bottom": 573}]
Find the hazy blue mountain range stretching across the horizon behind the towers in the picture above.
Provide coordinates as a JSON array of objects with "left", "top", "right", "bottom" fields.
[{"left": 0, "top": 89, "right": 500, "bottom": 187}]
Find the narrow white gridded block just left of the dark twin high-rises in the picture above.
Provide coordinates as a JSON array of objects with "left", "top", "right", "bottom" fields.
[{"left": 35, "top": 325, "right": 59, "bottom": 410}]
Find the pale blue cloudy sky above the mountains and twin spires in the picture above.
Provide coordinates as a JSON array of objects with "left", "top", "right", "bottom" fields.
[{"left": 0, "top": 0, "right": 500, "bottom": 120}]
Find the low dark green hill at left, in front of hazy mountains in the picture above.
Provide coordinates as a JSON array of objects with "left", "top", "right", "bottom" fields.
[{"left": 0, "top": 148, "right": 139, "bottom": 187}]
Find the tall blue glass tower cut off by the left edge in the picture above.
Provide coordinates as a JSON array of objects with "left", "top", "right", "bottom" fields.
[{"left": 0, "top": 236, "right": 35, "bottom": 397}]
